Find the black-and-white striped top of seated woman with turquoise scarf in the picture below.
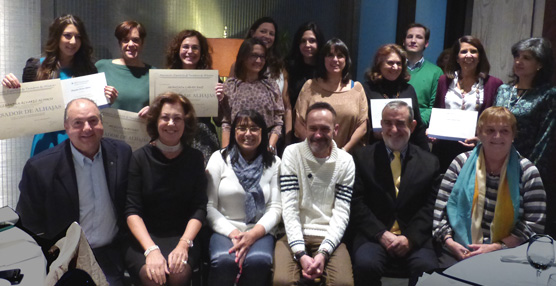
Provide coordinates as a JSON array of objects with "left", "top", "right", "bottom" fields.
[{"left": 433, "top": 152, "right": 546, "bottom": 243}]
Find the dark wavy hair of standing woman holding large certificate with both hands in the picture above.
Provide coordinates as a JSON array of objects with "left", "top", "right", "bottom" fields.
[{"left": 166, "top": 30, "right": 212, "bottom": 70}]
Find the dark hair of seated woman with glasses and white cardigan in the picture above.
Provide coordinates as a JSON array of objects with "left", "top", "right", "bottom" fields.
[{"left": 222, "top": 109, "right": 276, "bottom": 168}]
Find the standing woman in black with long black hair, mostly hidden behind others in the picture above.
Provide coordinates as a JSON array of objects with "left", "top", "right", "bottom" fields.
[{"left": 286, "top": 22, "right": 324, "bottom": 141}]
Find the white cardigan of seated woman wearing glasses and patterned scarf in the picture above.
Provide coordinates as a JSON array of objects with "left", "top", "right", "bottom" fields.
[{"left": 206, "top": 150, "right": 282, "bottom": 236}]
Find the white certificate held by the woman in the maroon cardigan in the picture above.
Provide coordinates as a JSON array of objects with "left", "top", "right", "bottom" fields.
[{"left": 428, "top": 108, "right": 478, "bottom": 141}]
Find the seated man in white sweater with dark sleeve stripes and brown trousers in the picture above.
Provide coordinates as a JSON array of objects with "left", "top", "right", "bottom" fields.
[{"left": 274, "top": 102, "right": 355, "bottom": 285}]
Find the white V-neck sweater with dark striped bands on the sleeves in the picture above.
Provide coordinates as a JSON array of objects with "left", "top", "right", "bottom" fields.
[{"left": 280, "top": 140, "right": 355, "bottom": 253}]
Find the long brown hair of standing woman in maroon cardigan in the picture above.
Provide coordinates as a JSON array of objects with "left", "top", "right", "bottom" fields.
[{"left": 445, "top": 36, "right": 490, "bottom": 79}]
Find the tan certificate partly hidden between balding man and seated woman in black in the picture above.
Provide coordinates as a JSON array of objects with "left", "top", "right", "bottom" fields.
[{"left": 100, "top": 108, "right": 151, "bottom": 151}]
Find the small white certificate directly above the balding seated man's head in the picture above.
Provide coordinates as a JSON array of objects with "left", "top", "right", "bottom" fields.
[{"left": 61, "top": 72, "right": 108, "bottom": 107}]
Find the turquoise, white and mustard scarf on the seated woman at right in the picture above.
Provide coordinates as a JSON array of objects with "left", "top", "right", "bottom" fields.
[{"left": 446, "top": 144, "right": 521, "bottom": 246}]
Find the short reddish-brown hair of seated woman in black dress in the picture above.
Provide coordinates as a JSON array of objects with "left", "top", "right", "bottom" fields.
[{"left": 147, "top": 92, "right": 197, "bottom": 145}]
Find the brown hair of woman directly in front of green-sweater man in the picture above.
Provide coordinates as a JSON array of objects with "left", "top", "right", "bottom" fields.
[{"left": 365, "top": 44, "right": 410, "bottom": 83}]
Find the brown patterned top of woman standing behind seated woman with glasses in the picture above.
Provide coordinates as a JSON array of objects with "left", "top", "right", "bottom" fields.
[{"left": 222, "top": 77, "right": 284, "bottom": 135}]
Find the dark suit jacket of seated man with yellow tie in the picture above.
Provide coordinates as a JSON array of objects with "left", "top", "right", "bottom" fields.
[{"left": 350, "top": 142, "right": 440, "bottom": 248}]
